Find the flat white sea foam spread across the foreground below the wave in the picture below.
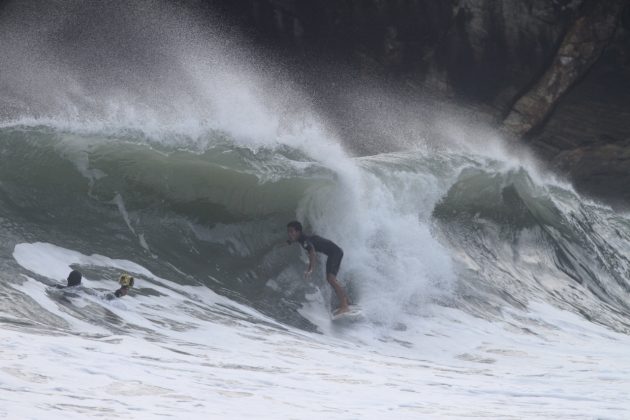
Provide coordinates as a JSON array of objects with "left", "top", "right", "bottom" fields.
[{"left": 0, "top": 244, "right": 630, "bottom": 419}]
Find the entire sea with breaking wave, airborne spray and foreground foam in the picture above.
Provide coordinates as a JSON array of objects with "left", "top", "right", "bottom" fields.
[{"left": 0, "top": 1, "right": 630, "bottom": 419}]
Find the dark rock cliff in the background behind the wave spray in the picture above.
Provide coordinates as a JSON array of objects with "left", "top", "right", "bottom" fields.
[{"left": 208, "top": 0, "right": 630, "bottom": 205}]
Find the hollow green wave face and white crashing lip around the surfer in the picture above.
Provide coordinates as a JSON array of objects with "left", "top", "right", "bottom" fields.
[{"left": 2, "top": 126, "right": 464, "bottom": 325}]
